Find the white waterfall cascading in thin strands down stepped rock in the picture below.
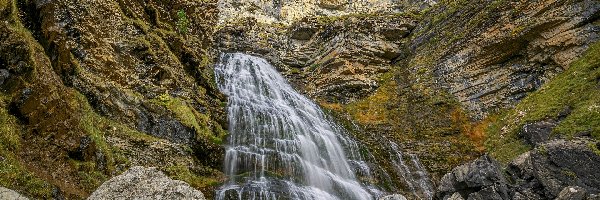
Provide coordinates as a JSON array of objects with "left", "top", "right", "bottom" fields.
[{"left": 215, "top": 53, "right": 376, "bottom": 200}]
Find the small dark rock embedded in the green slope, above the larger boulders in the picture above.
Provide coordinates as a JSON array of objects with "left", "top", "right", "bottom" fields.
[{"left": 519, "top": 120, "right": 558, "bottom": 146}]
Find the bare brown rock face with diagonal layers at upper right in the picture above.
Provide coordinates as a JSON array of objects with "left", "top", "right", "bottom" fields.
[{"left": 410, "top": 0, "right": 600, "bottom": 119}]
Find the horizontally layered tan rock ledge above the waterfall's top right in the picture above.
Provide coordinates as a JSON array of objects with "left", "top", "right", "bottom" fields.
[{"left": 218, "top": 14, "right": 417, "bottom": 104}]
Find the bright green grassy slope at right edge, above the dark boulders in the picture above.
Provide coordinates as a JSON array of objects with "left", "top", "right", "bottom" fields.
[{"left": 486, "top": 42, "right": 600, "bottom": 161}]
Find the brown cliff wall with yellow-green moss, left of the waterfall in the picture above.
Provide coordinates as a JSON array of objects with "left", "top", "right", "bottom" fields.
[{"left": 0, "top": 0, "right": 226, "bottom": 199}]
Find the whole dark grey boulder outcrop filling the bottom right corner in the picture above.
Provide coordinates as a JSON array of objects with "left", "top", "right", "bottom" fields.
[{"left": 436, "top": 138, "right": 600, "bottom": 199}]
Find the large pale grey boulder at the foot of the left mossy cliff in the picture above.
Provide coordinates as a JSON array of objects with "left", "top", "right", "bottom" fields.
[{"left": 88, "top": 166, "right": 204, "bottom": 200}]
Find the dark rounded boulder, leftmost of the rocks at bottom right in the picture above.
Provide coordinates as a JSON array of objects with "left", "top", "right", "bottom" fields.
[{"left": 436, "top": 155, "right": 508, "bottom": 199}]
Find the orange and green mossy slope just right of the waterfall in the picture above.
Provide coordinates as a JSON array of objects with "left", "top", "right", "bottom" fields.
[{"left": 320, "top": 66, "right": 482, "bottom": 184}]
